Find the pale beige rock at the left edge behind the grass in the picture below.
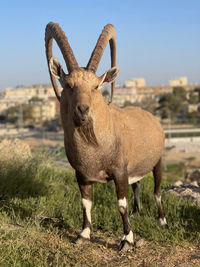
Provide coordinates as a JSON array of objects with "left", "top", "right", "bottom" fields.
[{"left": 0, "top": 139, "right": 32, "bottom": 161}]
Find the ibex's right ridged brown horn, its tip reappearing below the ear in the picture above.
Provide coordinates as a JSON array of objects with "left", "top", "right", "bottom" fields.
[{"left": 86, "top": 24, "right": 117, "bottom": 103}]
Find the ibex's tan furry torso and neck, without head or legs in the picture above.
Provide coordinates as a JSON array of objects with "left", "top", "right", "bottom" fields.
[{"left": 61, "top": 83, "right": 164, "bottom": 182}]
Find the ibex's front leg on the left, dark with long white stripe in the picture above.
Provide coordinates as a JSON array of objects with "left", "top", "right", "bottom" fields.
[{"left": 76, "top": 173, "right": 92, "bottom": 244}]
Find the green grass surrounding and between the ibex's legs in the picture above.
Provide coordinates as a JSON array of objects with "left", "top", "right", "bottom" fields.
[{"left": 0, "top": 156, "right": 200, "bottom": 266}]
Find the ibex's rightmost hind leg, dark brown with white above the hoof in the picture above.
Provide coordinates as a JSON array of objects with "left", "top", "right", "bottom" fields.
[{"left": 153, "top": 159, "right": 167, "bottom": 225}]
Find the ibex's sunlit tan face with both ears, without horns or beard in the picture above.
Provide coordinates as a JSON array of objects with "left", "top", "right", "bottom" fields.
[{"left": 49, "top": 57, "right": 119, "bottom": 127}]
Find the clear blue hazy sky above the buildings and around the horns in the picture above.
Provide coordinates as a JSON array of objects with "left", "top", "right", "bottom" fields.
[{"left": 0, "top": 0, "right": 200, "bottom": 90}]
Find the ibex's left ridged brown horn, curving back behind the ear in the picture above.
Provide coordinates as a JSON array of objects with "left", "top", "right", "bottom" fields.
[{"left": 45, "top": 22, "right": 79, "bottom": 101}]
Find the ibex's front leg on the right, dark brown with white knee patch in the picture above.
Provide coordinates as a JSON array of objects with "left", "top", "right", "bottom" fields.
[{"left": 114, "top": 172, "right": 134, "bottom": 251}]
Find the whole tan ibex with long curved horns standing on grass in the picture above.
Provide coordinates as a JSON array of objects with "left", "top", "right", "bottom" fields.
[{"left": 45, "top": 22, "right": 166, "bottom": 250}]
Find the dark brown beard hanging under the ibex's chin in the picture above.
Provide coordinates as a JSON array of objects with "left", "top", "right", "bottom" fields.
[{"left": 77, "top": 117, "right": 98, "bottom": 147}]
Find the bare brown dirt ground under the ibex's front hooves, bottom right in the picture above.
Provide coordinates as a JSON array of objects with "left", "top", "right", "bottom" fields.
[{"left": 63, "top": 233, "right": 200, "bottom": 267}]
